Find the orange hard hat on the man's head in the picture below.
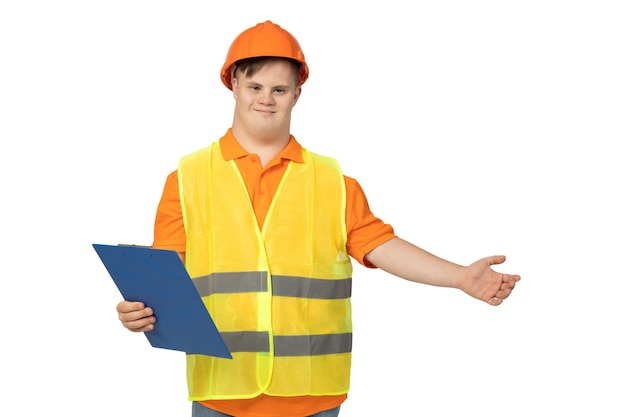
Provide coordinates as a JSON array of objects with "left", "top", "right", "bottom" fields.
[{"left": 221, "top": 20, "right": 309, "bottom": 90}]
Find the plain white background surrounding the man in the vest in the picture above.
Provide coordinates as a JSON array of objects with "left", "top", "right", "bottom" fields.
[{"left": 0, "top": 0, "right": 626, "bottom": 417}]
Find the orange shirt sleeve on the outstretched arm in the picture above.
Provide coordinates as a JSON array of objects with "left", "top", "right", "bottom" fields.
[{"left": 344, "top": 176, "right": 396, "bottom": 268}]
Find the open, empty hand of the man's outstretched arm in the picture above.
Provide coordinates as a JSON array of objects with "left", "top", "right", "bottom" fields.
[{"left": 459, "top": 255, "right": 521, "bottom": 306}]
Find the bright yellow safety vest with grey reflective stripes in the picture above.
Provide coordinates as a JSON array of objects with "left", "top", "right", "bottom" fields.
[{"left": 178, "top": 142, "right": 352, "bottom": 400}]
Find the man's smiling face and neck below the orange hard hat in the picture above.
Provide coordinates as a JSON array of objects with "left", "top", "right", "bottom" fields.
[{"left": 232, "top": 59, "right": 301, "bottom": 142}]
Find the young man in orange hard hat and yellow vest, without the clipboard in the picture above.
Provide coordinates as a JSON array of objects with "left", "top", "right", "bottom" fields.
[{"left": 117, "top": 21, "right": 520, "bottom": 417}]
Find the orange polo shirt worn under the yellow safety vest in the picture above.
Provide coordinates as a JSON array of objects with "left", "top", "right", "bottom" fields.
[{"left": 152, "top": 129, "right": 396, "bottom": 417}]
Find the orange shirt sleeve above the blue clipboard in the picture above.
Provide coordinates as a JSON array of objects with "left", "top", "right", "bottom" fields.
[{"left": 152, "top": 171, "right": 187, "bottom": 252}]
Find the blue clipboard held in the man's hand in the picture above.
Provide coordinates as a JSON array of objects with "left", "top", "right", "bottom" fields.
[{"left": 93, "top": 244, "right": 232, "bottom": 359}]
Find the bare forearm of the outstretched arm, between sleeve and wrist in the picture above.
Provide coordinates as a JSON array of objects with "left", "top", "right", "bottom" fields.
[{"left": 366, "top": 238, "right": 465, "bottom": 288}]
